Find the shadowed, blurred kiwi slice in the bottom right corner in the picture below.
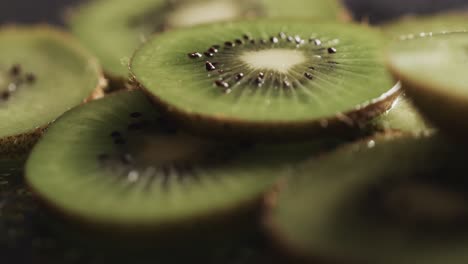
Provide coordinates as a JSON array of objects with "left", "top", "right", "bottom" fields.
[{"left": 266, "top": 135, "right": 468, "bottom": 264}]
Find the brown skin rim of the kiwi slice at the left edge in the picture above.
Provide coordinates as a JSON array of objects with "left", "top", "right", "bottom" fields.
[{"left": 0, "top": 24, "right": 107, "bottom": 159}]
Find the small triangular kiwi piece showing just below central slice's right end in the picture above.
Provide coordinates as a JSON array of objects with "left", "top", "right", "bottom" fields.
[{"left": 368, "top": 94, "right": 433, "bottom": 134}]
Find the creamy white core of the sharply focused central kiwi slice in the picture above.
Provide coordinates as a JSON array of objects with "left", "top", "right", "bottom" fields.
[{"left": 240, "top": 49, "right": 306, "bottom": 73}]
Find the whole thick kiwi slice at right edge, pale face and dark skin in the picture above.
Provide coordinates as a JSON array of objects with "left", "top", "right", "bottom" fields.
[{"left": 387, "top": 32, "right": 468, "bottom": 138}]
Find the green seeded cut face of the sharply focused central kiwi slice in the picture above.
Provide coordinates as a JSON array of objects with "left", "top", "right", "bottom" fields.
[{"left": 131, "top": 20, "right": 393, "bottom": 122}]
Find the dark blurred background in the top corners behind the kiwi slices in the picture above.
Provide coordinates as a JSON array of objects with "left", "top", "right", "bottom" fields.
[{"left": 0, "top": 0, "right": 468, "bottom": 24}]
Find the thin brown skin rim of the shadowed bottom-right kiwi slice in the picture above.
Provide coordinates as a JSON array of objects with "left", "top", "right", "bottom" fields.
[{"left": 261, "top": 131, "right": 412, "bottom": 264}]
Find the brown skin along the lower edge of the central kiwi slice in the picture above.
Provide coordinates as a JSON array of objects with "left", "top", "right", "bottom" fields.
[{"left": 131, "top": 76, "right": 401, "bottom": 142}]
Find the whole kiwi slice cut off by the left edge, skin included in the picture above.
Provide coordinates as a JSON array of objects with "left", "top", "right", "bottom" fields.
[{"left": 0, "top": 26, "right": 103, "bottom": 158}]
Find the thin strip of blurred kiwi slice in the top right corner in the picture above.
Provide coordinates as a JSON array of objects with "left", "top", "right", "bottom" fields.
[{"left": 382, "top": 12, "right": 468, "bottom": 37}]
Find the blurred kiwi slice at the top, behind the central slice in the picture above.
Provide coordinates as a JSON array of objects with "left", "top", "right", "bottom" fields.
[{"left": 71, "top": 0, "right": 342, "bottom": 76}]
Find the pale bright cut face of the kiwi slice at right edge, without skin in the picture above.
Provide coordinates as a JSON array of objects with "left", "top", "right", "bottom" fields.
[{"left": 388, "top": 32, "right": 468, "bottom": 100}]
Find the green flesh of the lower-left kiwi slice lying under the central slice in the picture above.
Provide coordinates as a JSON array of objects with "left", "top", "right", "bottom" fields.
[{"left": 26, "top": 91, "right": 340, "bottom": 234}]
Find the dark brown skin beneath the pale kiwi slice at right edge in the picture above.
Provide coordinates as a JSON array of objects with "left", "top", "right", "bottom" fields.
[{"left": 387, "top": 63, "right": 468, "bottom": 141}]
